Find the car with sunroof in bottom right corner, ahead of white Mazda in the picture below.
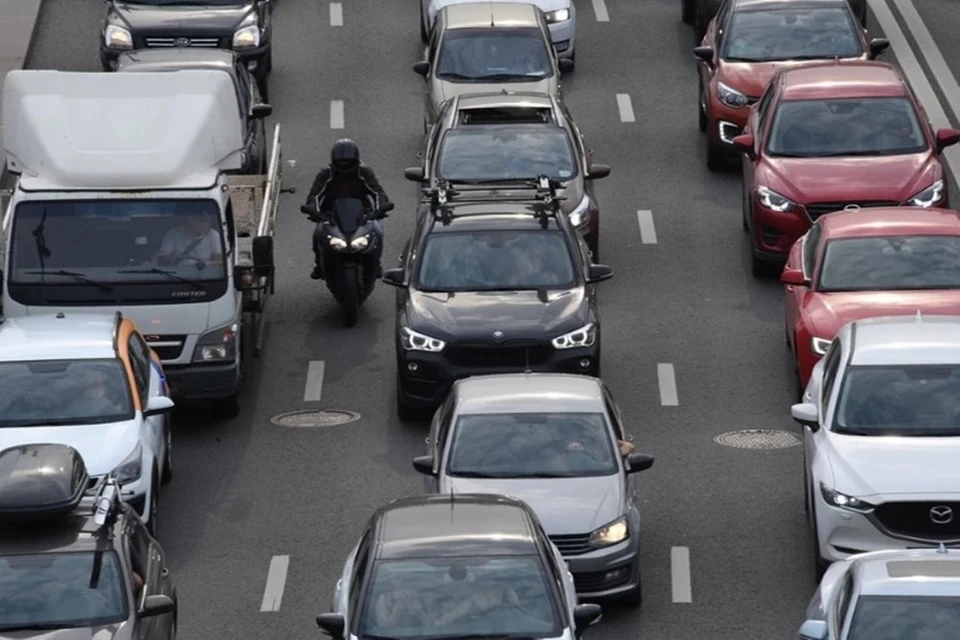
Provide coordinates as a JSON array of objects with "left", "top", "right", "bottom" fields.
[{"left": 799, "top": 545, "right": 960, "bottom": 640}]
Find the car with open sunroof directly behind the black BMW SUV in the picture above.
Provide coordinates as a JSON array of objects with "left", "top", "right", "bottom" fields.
[{"left": 404, "top": 92, "right": 610, "bottom": 260}]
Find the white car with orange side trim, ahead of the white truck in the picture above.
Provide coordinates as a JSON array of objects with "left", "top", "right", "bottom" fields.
[{"left": 0, "top": 312, "right": 174, "bottom": 535}]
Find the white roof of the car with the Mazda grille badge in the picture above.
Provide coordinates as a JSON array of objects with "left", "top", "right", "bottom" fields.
[{"left": 850, "top": 311, "right": 960, "bottom": 366}]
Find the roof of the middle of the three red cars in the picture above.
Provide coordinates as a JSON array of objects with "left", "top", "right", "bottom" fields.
[{"left": 780, "top": 60, "right": 908, "bottom": 100}]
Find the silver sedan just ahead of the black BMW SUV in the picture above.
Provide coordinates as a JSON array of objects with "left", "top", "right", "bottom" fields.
[{"left": 413, "top": 373, "right": 653, "bottom": 604}]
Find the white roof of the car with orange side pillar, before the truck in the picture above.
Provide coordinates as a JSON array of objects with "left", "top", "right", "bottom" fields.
[{"left": 0, "top": 313, "right": 118, "bottom": 362}]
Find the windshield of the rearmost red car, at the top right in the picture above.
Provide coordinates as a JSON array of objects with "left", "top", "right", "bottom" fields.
[{"left": 722, "top": 7, "right": 863, "bottom": 62}]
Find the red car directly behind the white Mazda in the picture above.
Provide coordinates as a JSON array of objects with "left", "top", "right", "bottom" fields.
[{"left": 780, "top": 207, "right": 960, "bottom": 392}]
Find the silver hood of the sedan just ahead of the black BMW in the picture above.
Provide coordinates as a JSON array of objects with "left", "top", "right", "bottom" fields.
[{"left": 441, "top": 474, "right": 624, "bottom": 535}]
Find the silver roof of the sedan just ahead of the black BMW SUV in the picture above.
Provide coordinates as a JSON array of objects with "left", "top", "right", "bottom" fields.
[{"left": 456, "top": 373, "right": 604, "bottom": 415}]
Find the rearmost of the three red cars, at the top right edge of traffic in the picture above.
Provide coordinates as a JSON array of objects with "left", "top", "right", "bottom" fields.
[{"left": 693, "top": 0, "right": 890, "bottom": 171}]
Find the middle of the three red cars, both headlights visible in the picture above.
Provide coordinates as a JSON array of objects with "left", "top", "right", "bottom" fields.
[{"left": 733, "top": 61, "right": 960, "bottom": 276}]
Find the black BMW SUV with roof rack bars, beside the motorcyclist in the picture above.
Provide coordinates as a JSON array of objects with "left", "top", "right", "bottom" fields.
[{"left": 383, "top": 176, "right": 613, "bottom": 420}]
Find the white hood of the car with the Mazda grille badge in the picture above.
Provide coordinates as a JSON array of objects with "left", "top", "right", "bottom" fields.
[{"left": 827, "top": 433, "right": 960, "bottom": 500}]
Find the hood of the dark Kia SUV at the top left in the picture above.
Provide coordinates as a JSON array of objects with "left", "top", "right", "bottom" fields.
[{"left": 113, "top": 1, "right": 253, "bottom": 36}]
